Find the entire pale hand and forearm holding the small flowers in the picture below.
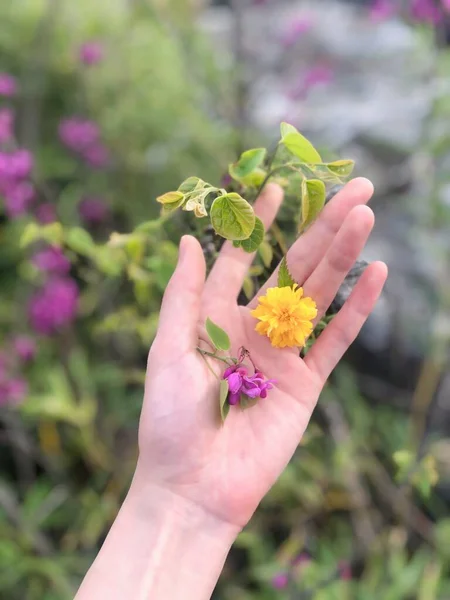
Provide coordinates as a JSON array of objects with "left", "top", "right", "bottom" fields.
[{"left": 76, "top": 178, "right": 387, "bottom": 600}]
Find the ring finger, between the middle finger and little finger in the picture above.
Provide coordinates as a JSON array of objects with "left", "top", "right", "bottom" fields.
[{"left": 303, "top": 206, "right": 375, "bottom": 321}]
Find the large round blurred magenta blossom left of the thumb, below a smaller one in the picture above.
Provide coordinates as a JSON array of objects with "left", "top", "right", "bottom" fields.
[{"left": 28, "top": 277, "right": 78, "bottom": 335}]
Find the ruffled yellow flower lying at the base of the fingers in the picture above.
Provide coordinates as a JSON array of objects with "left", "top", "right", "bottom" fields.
[{"left": 251, "top": 285, "right": 317, "bottom": 348}]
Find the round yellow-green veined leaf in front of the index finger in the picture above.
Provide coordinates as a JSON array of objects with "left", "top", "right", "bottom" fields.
[{"left": 211, "top": 192, "right": 256, "bottom": 240}]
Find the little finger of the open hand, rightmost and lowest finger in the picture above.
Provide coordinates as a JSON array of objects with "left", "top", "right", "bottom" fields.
[{"left": 305, "top": 262, "right": 388, "bottom": 382}]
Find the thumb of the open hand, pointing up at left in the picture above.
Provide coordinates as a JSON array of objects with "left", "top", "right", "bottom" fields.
[{"left": 154, "top": 235, "right": 206, "bottom": 354}]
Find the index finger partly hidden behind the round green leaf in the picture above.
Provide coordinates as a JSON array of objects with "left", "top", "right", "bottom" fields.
[{"left": 205, "top": 183, "right": 283, "bottom": 300}]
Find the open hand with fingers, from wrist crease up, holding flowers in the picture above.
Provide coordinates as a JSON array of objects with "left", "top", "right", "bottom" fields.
[{"left": 139, "top": 179, "right": 387, "bottom": 527}]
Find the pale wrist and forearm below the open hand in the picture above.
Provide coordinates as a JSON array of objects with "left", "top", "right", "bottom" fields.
[{"left": 76, "top": 466, "right": 238, "bottom": 600}]
